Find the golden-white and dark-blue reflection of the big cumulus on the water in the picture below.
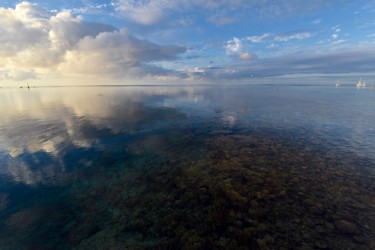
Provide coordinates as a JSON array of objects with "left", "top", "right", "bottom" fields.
[{"left": 0, "top": 88, "right": 201, "bottom": 184}]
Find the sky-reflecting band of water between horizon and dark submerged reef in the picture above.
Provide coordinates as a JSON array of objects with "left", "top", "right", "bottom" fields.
[{"left": 0, "top": 86, "right": 375, "bottom": 184}]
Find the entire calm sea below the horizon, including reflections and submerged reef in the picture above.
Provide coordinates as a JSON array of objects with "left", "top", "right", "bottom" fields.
[{"left": 0, "top": 86, "right": 375, "bottom": 249}]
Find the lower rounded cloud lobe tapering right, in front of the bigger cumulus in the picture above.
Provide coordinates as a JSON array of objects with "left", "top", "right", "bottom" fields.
[{"left": 59, "top": 29, "right": 185, "bottom": 76}]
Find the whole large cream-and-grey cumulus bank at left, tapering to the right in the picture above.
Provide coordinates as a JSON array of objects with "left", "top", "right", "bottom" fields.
[{"left": 0, "top": 2, "right": 186, "bottom": 80}]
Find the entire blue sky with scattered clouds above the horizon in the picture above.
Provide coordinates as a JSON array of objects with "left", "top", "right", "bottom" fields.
[{"left": 0, "top": 0, "right": 375, "bottom": 87}]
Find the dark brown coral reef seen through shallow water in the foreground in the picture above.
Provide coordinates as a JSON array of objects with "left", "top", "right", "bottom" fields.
[{"left": 0, "top": 124, "right": 375, "bottom": 250}]
